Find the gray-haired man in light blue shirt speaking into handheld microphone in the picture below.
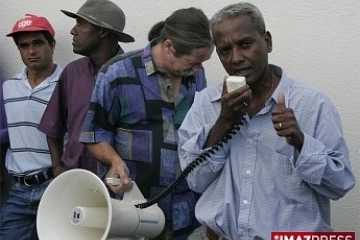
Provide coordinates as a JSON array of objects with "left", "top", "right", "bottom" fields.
[{"left": 178, "top": 2, "right": 355, "bottom": 240}]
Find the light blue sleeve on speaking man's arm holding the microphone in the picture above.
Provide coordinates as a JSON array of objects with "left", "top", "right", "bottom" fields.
[{"left": 178, "top": 92, "right": 228, "bottom": 193}]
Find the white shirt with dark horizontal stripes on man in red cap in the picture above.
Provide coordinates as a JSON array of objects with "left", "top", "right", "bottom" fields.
[{"left": 3, "top": 66, "right": 62, "bottom": 176}]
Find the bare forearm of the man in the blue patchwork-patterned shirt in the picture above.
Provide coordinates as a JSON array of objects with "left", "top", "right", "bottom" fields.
[{"left": 87, "top": 142, "right": 123, "bottom": 166}]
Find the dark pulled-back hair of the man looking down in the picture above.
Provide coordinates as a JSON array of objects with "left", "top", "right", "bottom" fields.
[{"left": 154, "top": 7, "right": 213, "bottom": 55}]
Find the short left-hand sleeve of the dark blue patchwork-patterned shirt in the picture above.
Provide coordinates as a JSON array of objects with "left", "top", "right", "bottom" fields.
[{"left": 80, "top": 69, "right": 120, "bottom": 143}]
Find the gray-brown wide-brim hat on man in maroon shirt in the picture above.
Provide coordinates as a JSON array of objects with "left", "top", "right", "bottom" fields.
[{"left": 61, "top": 0, "right": 135, "bottom": 42}]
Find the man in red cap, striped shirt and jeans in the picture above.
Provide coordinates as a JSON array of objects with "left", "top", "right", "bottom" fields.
[{"left": 0, "top": 14, "right": 62, "bottom": 240}]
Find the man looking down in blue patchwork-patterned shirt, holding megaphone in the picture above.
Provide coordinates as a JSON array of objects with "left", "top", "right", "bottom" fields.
[{"left": 80, "top": 8, "right": 214, "bottom": 240}]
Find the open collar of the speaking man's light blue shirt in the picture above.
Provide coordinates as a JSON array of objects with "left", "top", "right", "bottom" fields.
[{"left": 211, "top": 64, "right": 291, "bottom": 106}]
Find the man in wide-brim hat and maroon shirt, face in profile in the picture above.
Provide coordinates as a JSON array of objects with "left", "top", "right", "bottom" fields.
[{"left": 39, "top": 0, "right": 135, "bottom": 180}]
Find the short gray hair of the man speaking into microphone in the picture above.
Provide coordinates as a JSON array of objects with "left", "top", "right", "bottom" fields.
[{"left": 210, "top": 2, "right": 266, "bottom": 35}]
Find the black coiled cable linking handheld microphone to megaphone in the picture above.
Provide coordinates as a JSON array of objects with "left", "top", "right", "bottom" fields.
[{"left": 135, "top": 118, "right": 245, "bottom": 209}]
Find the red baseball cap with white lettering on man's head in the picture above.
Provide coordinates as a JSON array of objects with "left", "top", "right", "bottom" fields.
[{"left": 6, "top": 14, "right": 55, "bottom": 37}]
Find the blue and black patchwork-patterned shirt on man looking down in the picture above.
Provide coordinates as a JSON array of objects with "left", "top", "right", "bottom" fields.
[{"left": 80, "top": 42, "right": 206, "bottom": 239}]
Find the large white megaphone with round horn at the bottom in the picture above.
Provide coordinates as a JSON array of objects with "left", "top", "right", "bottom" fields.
[{"left": 36, "top": 169, "right": 165, "bottom": 240}]
